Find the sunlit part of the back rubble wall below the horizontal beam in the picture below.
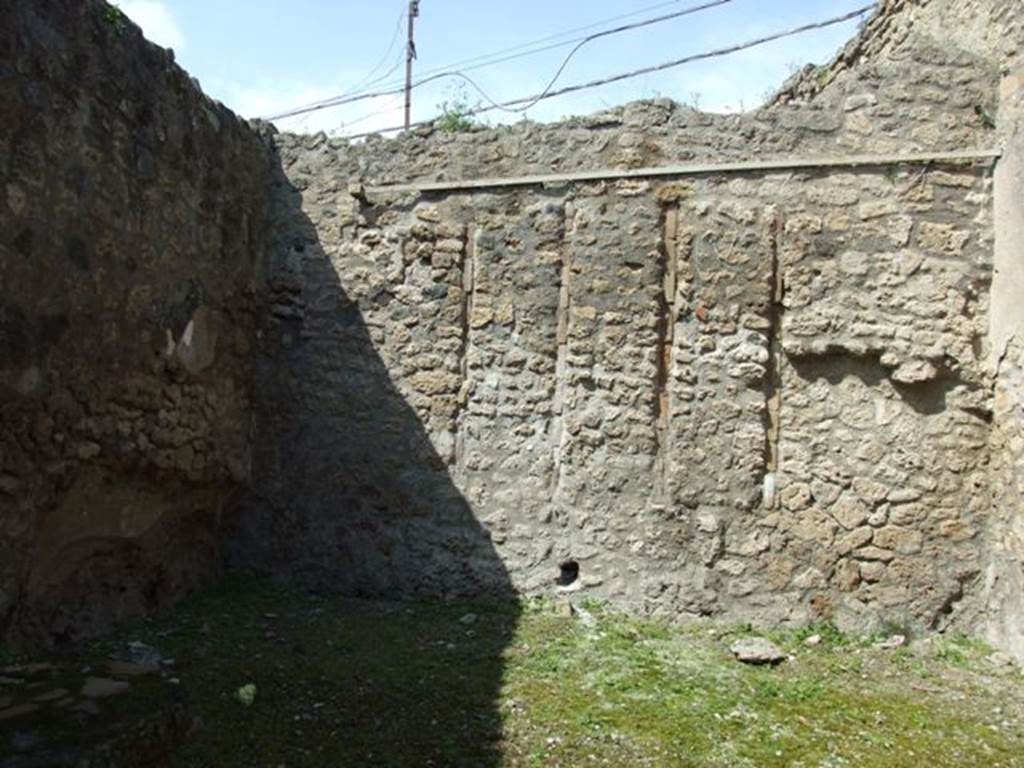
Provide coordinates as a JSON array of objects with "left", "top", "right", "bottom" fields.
[{"left": 257, "top": 148, "right": 991, "bottom": 627}]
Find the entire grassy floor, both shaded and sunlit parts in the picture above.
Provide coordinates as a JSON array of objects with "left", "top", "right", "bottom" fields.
[{"left": 25, "top": 581, "right": 1024, "bottom": 768}]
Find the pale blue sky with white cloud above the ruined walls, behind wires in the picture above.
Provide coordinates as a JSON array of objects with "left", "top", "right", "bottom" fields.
[{"left": 119, "top": 0, "right": 869, "bottom": 135}]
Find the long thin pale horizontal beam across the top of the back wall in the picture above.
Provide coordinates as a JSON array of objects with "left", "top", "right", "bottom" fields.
[{"left": 366, "top": 150, "right": 999, "bottom": 195}]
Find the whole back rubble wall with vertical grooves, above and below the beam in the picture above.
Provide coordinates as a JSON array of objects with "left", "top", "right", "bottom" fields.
[{"left": 253, "top": 0, "right": 999, "bottom": 630}]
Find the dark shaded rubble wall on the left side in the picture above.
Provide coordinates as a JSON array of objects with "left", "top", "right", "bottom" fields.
[{"left": 0, "top": 0, "right": 270, "bottom": 643}]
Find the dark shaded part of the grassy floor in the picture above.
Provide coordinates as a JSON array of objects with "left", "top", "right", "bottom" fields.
[{"left": 149, "top": 580, "right": 518, "bottom": 767}]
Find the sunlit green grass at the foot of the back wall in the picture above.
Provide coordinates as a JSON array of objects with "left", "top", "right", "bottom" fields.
[{"left": 509, "top": 616, "right": 1024, "bottom": 767}]
